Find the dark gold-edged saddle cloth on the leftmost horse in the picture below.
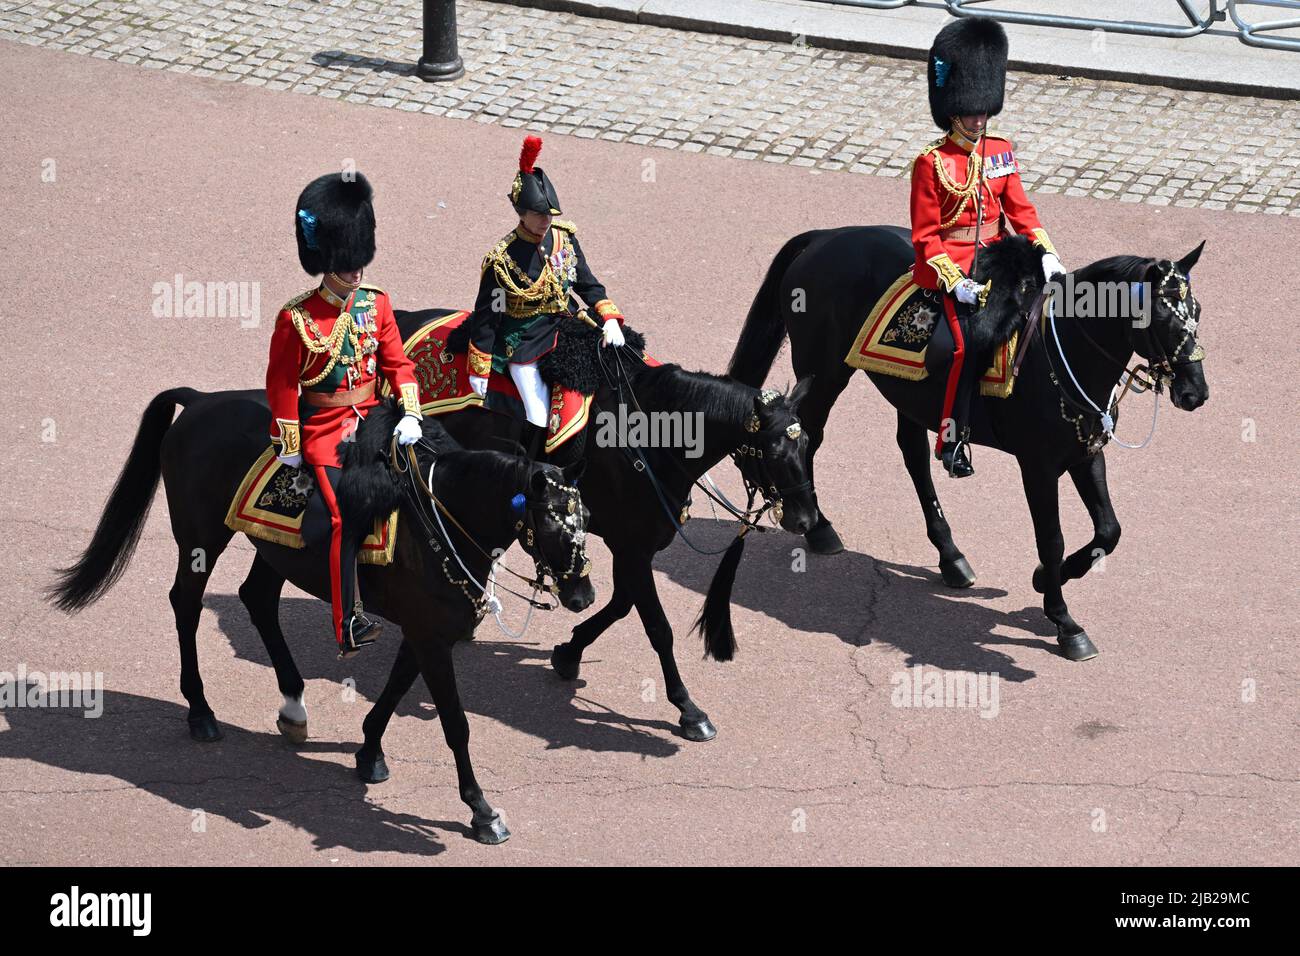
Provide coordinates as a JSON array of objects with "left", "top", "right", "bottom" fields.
[{"left": 226, "top": 446, "right": 398, "bottom": 564}]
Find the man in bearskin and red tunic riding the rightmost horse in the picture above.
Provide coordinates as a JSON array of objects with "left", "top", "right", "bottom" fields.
[{"left": 911, "top": 18, "right": 1065, "bottom": 477}]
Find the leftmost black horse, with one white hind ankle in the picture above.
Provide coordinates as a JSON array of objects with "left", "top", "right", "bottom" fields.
[{"left": 49, "top": 389, "right": 595, "bottom": 843}]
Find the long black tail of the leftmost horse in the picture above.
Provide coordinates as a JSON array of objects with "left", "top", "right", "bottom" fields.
[{"left": 46, "top": 389, "right": 202, "bottom": 611}]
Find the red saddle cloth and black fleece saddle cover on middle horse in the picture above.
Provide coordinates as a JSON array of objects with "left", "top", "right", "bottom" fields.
[{"left": 413, "top": 311, "right": 659, "bottom": 455}]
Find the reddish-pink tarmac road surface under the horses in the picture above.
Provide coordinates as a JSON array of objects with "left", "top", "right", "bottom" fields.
[{"left": 0, "top": 44, "right": 1300, "bottom": 865}]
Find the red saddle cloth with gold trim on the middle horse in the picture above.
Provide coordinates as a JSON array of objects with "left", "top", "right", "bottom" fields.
[{"left": 384, "top": 312, "right": 603, "bottom": 453}]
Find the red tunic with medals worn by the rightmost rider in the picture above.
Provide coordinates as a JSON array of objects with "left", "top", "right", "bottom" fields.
[{"left": 911, "top": 133, "right": 1056, "bottom": 293}]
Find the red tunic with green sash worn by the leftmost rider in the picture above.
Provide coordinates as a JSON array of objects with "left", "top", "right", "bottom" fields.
[{"left": 267, "top": 284, "right": 420, "bottom": 468}]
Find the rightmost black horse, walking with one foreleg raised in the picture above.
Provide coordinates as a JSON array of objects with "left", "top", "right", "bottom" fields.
[{"left": 729, "top": 226, "right": 1209, "bottom": 661}]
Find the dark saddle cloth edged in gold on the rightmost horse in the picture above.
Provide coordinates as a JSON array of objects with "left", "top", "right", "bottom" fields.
[{"left": 844, "top": 269, "right": 1019, "bottom": 398}]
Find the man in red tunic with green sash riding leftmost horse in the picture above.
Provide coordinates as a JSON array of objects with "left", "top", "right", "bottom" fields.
[{"left": 267, "top": 173, "right": 420, "bottom": 658}]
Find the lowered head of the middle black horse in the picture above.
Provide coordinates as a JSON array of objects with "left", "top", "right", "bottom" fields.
[{"left": 735, "top": 376, "right": 816, "bottom": 535}]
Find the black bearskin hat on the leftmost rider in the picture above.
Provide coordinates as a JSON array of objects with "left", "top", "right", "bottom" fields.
[{"left": 294, "top": 173, "right": 374, "bottom": 276}]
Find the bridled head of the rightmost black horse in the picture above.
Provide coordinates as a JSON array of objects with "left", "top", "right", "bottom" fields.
[{"left": 1128, "top": 242, "right": 1210, "bottom": 411}]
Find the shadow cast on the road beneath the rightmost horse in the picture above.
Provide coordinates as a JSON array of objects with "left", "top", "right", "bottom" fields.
[{"left": 655, "top": 519, "right": 1058, "bottom": 682}]
